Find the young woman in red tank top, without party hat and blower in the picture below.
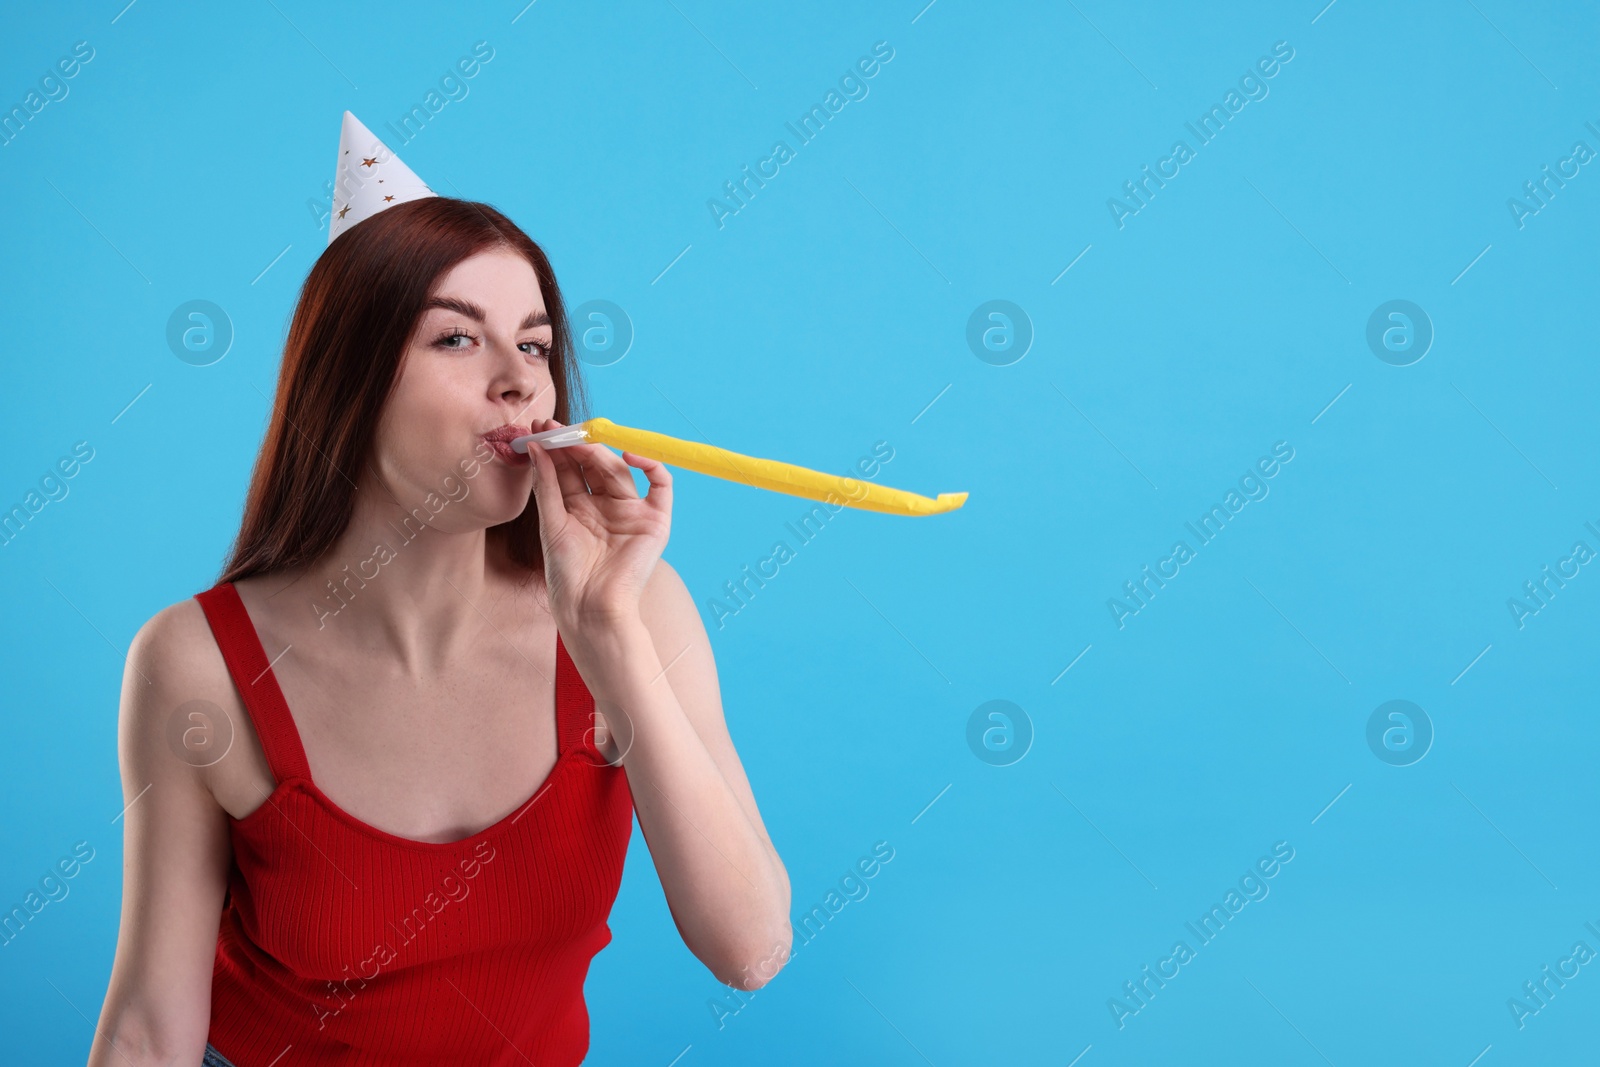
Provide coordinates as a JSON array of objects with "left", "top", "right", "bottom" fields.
[{"left": 90, "top": 197, "right": 790, "bottom": 1067}]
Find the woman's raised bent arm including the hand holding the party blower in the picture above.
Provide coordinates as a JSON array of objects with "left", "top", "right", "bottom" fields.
[{"left": 528, "top": 419, "right": 794, "bottom": 989}]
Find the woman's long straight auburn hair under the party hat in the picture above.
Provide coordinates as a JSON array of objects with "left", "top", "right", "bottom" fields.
[{"left": 218, "top": 197, "right": 589, "bottom": 582}]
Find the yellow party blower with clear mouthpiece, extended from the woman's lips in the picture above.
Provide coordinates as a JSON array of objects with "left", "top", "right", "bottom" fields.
[{"left": 510, "top": 419, "right": 966, "bottom": 515}]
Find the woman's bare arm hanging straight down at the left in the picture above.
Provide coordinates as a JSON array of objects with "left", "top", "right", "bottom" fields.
[{"left": 88, "top": 598, "right": 233, "bottom": 1067}]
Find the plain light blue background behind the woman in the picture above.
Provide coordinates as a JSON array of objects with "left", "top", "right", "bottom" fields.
[{"left": 0, "top": 0, "right": 1600, "bottom": 1067}]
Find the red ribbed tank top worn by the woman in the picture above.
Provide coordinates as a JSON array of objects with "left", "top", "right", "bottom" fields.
[{"left": 195, "top": 582, "right": 634, "bottom": 1067}]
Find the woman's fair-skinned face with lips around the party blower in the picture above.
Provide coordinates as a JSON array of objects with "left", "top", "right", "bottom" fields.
[{"left": 374, "top": 250, "right": 555, "bottom": 533}]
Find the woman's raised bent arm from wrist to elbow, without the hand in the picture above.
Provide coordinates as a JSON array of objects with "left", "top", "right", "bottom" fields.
[{"left": 563, "top": 560, "right": 792, "bottom": 990}]
